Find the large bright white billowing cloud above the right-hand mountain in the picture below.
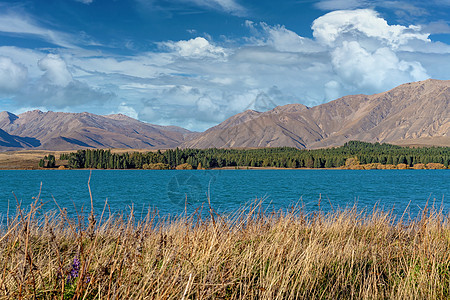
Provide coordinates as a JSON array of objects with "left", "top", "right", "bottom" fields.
[{"left": 312, "top": 9, "right": 431, "bottom": 92}]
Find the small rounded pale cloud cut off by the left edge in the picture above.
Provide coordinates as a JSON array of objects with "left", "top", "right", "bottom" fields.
[{"left": 0, "top": 56, "right": 28, "bottom": 93}]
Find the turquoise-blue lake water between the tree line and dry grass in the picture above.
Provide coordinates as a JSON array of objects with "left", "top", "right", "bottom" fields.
[{"left": 0, "top": 170, "right": 450, "bottom": 218}]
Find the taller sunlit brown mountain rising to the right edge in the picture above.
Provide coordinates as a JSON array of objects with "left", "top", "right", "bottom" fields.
[{"left": 183, "top": 79, "right": 450, "bottom": 148}]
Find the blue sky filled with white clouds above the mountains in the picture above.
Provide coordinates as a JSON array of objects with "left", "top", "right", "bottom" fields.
[{"left": 0, "top": 0, "right": 450, "bottom": 131}]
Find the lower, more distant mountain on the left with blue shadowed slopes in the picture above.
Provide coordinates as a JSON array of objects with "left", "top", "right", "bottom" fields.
[{"left": 0, "top": 110, "right": 191, "bottom": 150}]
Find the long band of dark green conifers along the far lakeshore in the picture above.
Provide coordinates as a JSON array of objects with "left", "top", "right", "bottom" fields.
[{"left": 46, "top": 141, "right": 450, "bottom": 169}]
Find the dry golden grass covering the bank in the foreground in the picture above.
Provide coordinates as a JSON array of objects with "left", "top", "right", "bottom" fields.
[{"left": 0, "top": 200, "right": 450, "bottom": 299}]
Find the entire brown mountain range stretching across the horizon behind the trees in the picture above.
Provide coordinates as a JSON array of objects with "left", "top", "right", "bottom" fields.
[{"left": 0, "top": 79, "right": 450, "bottom": 150}]
